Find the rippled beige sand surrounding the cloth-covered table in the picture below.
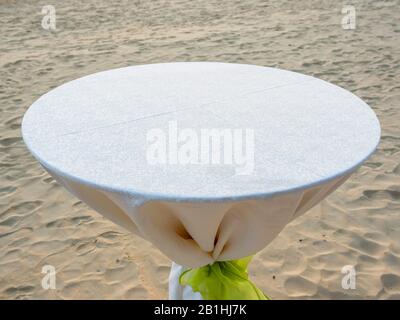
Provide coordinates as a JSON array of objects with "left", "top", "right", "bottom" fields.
[{"left": 0, "top": 0, "right": 400, "bottom": 299}]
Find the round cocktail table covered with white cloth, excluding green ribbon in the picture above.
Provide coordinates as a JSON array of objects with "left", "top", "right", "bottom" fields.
[{"left": 22, "top": 62, "right": 380, "bottom": 299}]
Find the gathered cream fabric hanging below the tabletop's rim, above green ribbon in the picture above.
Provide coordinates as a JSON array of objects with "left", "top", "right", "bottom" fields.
[{"left": 43, "top": 164, "right": 349, "bottom": 268}]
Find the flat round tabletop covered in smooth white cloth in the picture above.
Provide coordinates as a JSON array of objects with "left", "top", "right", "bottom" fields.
[{"left": 22, "top": 62, "right": 380, "bottom": 201}]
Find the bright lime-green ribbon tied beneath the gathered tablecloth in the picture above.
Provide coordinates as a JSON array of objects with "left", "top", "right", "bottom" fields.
[{"left": 179, "top": 256, "right": 269, "bottom": 300}]
